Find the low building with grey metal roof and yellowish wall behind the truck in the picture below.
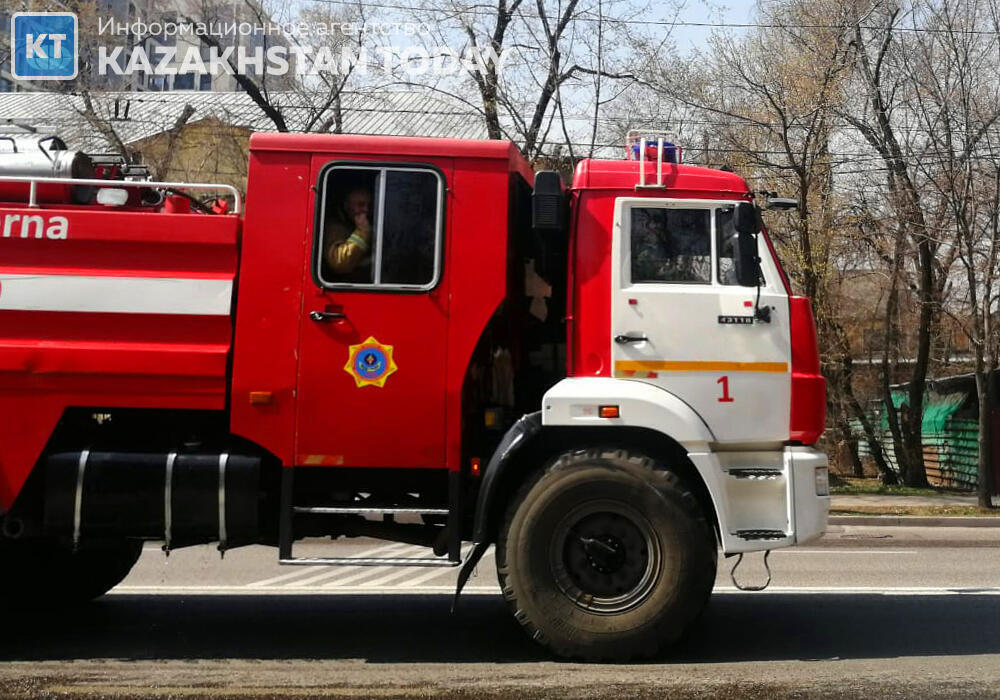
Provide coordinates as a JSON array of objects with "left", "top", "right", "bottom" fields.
[{"left": 0, "top": 91, "right": 487, "bottom": 190}]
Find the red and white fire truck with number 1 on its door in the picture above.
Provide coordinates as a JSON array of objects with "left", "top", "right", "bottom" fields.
[{"left": 0, "top": 134, "right": 829, "bottom": 659}]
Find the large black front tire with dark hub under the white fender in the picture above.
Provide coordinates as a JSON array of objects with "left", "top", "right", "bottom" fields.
[{"left": 496, "top": 449, "right": 717, "bottom": 661}]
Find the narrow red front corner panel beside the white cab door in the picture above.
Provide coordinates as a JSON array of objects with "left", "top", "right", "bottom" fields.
[{"left": 788, "top": 296, "right": 826, "bottom": 445}]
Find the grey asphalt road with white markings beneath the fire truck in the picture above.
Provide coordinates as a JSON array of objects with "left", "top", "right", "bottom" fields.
[{"left": 0, "top": 527, "right": 1000, "bottom": 698}]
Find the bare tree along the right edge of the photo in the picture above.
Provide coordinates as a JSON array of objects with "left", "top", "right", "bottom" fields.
[{"left": 904, "top": 0, "right": 1000, "bottom": 507}]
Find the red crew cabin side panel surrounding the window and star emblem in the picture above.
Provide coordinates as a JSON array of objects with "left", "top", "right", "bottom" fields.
[{"left": 232, "top": 134, "right": 533, "bottom": 469}]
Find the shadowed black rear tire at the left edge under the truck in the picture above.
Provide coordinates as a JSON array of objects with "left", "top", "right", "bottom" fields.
[{"left": 0, "top": 540, "right": 142, "bottom": 607}]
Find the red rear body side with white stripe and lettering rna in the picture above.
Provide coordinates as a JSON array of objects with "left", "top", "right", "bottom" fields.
[{"left": 0, "top": 206, "right": 240, "bottom": 508}]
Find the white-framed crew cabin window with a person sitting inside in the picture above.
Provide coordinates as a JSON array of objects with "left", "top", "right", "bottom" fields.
[{"left": 316, "top": 166, "right": 444, "bottom": 289}]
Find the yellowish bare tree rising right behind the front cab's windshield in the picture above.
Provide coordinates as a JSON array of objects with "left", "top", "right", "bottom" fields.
[{"left": 632, "top": 0, "right": 894, "bottom": 482}]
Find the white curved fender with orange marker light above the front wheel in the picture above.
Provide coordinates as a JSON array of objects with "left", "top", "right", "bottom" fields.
[{"left": 542, "top": 377, "right": 715, "bottom": 452}]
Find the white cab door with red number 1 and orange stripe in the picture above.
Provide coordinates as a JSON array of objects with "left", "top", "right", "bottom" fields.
[{"left": 611, "top": 198, "right": 791, "bottom": 442}]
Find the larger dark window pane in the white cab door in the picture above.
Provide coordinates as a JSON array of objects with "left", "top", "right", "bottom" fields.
[{"left": 631, "top": 207, "right": 712, "bottom": 284}]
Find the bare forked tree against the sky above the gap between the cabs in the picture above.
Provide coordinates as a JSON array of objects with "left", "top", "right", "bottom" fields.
[{"left": 398, "top": 0, "right": 640, "bottom": 160}]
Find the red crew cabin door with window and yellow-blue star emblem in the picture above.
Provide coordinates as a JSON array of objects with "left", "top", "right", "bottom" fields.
[{"left": 295, "top": 161, "right": 452, "bottom": 467}]
